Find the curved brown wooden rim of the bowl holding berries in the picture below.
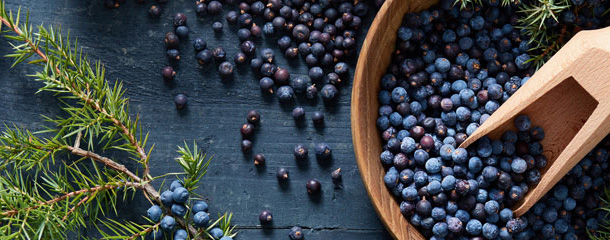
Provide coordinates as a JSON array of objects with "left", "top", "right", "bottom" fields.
[{"left": 351, "top": 0, "right": 438, "bottom": 239}]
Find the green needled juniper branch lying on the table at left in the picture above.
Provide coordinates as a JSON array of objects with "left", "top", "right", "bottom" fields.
[{"left": 0, "top": 1, "right": 234, "bottom": 239}]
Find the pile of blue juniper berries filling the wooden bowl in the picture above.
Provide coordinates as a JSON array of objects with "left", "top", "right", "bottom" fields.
[{"left": 377, "top": 0, "right": 608, "bottom": 239}]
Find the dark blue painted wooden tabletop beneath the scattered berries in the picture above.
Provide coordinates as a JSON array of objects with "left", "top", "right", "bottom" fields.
[{"left": 0, "top": 0, "right": 390, "bottom": 239}]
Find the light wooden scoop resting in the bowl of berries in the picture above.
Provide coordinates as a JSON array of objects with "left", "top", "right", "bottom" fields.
[{"left": 460, "top": 27, "right": 610, "bottom": 216}]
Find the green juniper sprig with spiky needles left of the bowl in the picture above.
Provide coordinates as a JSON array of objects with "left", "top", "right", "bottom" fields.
[{"left": 0, "top": 1, "right": 235, "bottom": 239}]
